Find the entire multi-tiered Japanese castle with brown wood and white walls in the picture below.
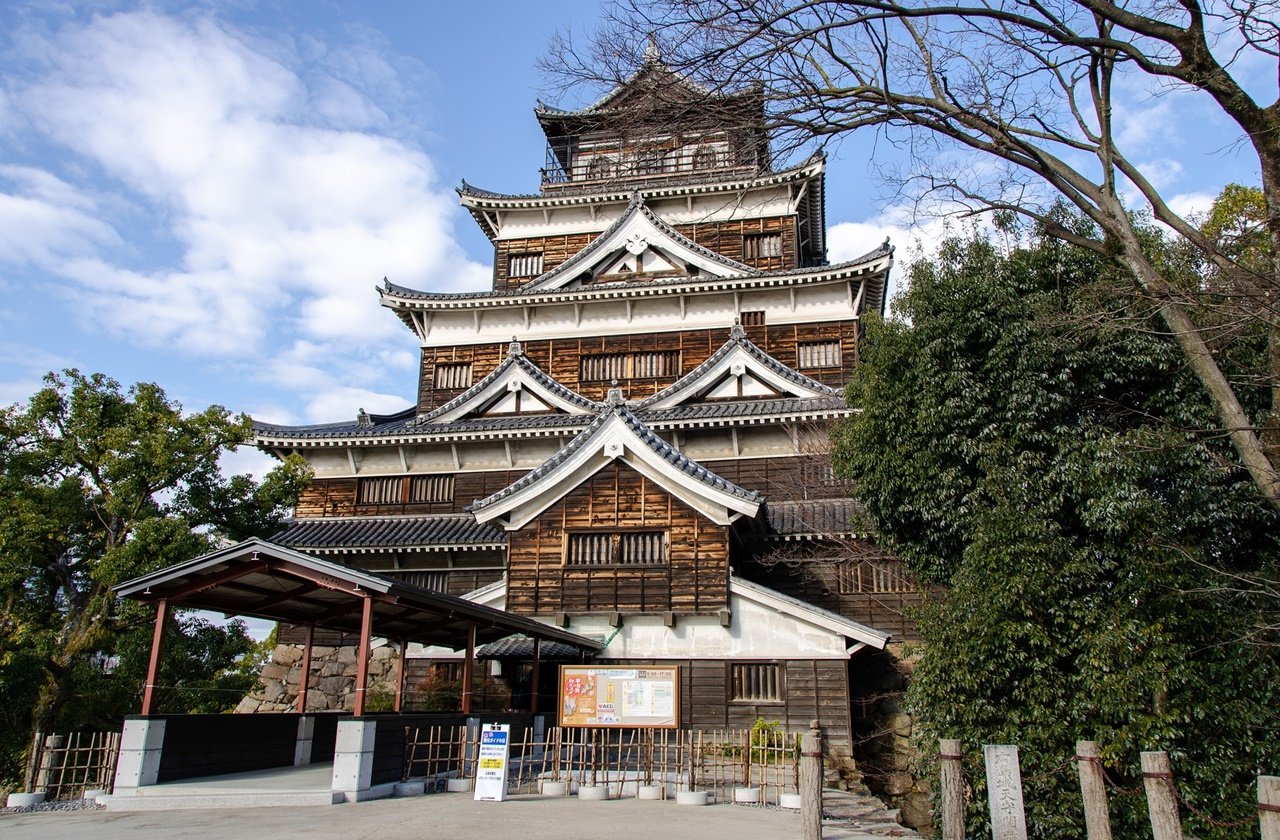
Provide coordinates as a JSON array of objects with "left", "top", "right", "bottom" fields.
[{"left": 256, "top": 54, "right": 915, "bottom": 749}]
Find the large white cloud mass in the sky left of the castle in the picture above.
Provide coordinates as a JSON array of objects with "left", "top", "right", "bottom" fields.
[{"left": 0, "top": 10, "right": 489, "bottom": 417}]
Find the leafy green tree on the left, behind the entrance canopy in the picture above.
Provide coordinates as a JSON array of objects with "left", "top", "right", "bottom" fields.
[{"left": 0, "top": 371, "right": 308, "bottom": 781}]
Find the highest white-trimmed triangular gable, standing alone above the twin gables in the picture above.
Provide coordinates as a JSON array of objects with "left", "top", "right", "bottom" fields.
[{"left": 520, "top": 192, "right": 759, "bottom": 292}]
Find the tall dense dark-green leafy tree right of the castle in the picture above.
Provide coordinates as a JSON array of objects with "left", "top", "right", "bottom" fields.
[{"left": 836, "top": 222, "right": 1280, "bottom": 837}]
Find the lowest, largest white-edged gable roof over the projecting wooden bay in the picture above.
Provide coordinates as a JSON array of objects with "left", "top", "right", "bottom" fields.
[{"left": 467, "top": 391, "right": 764, "bottom": 530}]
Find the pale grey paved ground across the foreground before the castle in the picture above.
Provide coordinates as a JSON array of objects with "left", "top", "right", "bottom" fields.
[{"left": 0, "top": 794, "right": 914, "bottom": 840}]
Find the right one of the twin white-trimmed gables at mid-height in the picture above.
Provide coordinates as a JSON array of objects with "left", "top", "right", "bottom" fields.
[{"left": 636, "top": 324, "right": 840, "bottom": 411}]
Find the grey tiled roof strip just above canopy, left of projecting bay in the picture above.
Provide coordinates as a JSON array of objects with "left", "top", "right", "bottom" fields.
[{"left": 271, "top": 513, "right": 507, "bottom": 551}]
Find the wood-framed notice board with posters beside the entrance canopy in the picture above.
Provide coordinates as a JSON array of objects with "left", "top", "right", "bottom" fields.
[{"left": 556, "top": 665, "right": 680, "bottom": 729}]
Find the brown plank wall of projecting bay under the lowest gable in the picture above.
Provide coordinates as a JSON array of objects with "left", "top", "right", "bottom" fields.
[{"left": 507, "top": 461, "right": 728, "bottom": 616}]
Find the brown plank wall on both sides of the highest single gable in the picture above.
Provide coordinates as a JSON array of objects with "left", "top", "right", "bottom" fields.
[{"left": 493, "top": 215, "right": 800, "bottom": 291}]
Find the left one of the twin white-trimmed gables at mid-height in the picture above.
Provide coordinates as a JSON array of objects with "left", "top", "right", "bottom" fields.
[{"left": 417, "top": 341, "right": 600, "bottom": 426}]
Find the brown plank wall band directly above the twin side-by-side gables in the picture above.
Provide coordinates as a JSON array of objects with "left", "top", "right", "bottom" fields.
[{"left": 419, "top": 321, "right": 858, "bottom": 412}]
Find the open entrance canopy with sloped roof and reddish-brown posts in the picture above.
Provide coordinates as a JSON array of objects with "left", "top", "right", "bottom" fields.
[{"left": 115, "top": 539, "right": 600, "bottom": 716}]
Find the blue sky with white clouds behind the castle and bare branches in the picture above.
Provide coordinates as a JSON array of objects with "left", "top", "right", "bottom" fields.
[{"left": 0, "top": 0, "right": 1274, "bottom": 478}]
